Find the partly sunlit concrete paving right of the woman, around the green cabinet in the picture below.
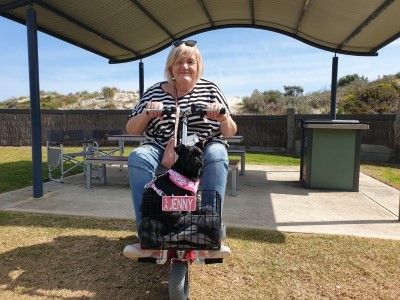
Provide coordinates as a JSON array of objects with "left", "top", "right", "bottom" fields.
[{"left": 224, "top": 166, "right": 400, "bottom": 239}]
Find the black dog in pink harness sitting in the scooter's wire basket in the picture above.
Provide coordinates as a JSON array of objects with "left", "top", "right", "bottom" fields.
[{"left": 140, "top": 142, "right": 203, "bottom": 245}]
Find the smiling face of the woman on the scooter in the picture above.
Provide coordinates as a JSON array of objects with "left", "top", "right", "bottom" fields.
[{"left": 172, "top": 53, "right": 197, "bottom": 84}]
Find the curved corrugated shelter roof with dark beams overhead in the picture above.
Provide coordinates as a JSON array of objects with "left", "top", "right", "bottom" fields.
[{"left": 0, "top": 0, "right": 400, "bottom": 63}]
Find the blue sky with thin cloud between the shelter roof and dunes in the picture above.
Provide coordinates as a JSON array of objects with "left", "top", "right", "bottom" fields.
[{"left": 0, "top": 16, "right": 400, "bottom": 101}]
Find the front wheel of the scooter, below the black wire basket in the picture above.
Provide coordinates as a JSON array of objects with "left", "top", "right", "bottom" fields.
[{"left": 168, "top": 262, "right": 189, "bottom": 300}]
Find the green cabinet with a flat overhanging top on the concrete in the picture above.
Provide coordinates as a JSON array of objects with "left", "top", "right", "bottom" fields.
[{"left": 300, "top": 120, "right": 368, "bottom": 191}]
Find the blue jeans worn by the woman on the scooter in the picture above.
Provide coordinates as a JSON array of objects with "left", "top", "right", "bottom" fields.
[{"left": 128, "top": 142, "right": 229, "bottom": 229}]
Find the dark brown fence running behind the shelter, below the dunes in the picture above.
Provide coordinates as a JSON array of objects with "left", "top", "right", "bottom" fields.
[{"left": 0, "top": 109, "right": 396, "bottom": 159}]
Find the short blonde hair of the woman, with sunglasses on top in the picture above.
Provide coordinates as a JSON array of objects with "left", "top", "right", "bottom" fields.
[{"left": 165, "top": 44, "right": 203, "bottom": 84}]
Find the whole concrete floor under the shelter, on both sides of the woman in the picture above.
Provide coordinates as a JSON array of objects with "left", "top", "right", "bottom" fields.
[{"left": 0, "top": 165, "right": 400, "bottom": 240}]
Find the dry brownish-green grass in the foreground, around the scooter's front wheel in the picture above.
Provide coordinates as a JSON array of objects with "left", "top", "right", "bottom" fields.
[{"left": 0, "top": 212, "right": 400, "bottom": 300}]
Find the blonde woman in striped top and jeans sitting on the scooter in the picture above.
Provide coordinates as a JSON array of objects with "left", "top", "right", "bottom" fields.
[{"left": 124, "top": 40, "right": 237, "bottom": 258}]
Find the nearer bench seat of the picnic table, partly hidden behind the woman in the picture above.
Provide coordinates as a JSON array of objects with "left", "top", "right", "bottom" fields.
[{"left": 85, "top": 155, "right": 239, "bottom": 197}]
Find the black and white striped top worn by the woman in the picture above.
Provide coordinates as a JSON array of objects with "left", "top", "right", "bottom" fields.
[{"left": 132, "top": 79, "right": 229, "bottom": 149}]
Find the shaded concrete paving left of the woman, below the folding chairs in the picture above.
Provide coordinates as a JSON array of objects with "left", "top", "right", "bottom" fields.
[{"left": 0, "top": 167, "right": 134, "bottom": 219}]
